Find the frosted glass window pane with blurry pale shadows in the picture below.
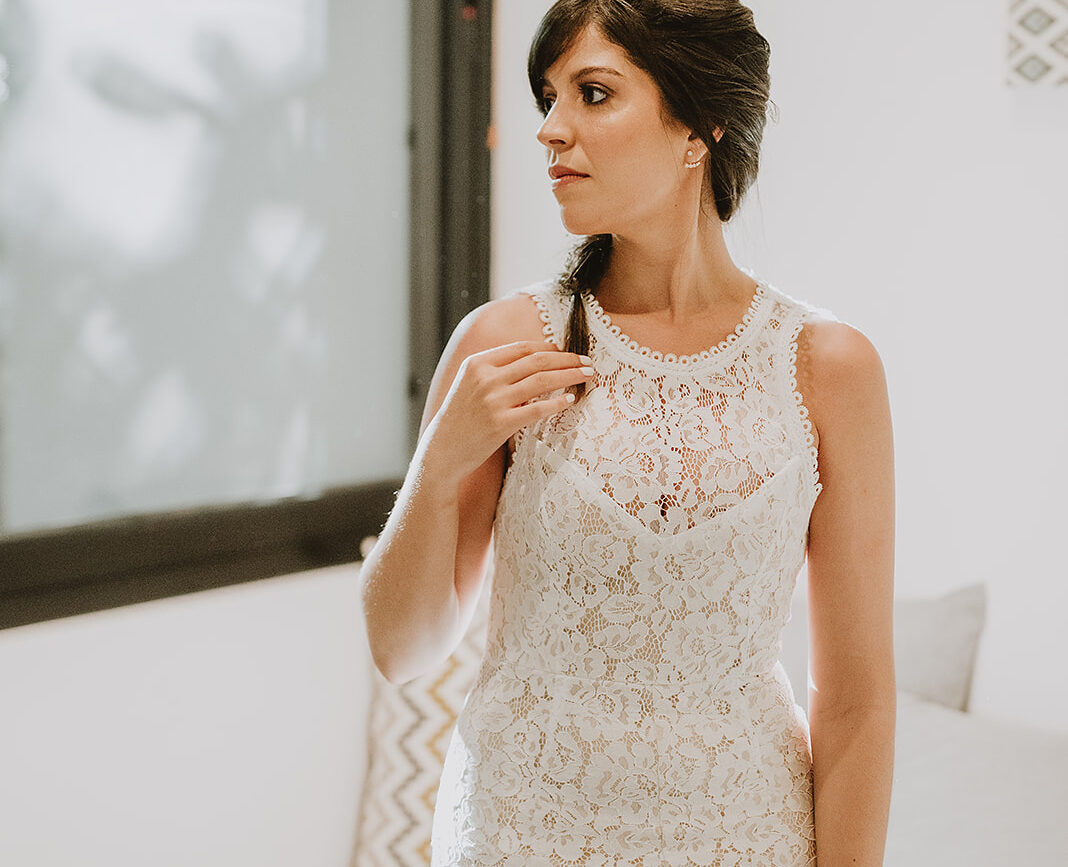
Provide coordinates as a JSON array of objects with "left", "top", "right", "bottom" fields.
[{"left": 0, "top": 0, "right": 409, "bottom": 533}]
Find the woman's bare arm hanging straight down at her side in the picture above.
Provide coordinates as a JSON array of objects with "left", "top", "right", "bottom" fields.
[{"left": 798, "top": 320, "right": 897, "bottom": 867}]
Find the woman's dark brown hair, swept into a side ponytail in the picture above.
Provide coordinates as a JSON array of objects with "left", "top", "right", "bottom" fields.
[{"left": 527, "top": 0, "right": 772, "bottom": 396}]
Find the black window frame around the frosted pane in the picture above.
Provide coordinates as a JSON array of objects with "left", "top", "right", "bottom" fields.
[{"left": 0, "top": 0, "right": 492, "bottom": 629}]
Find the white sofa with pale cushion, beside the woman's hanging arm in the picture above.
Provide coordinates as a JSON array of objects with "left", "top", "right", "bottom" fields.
[{"left": 883, "top": 585, "right": 1068, "bottom": 867}]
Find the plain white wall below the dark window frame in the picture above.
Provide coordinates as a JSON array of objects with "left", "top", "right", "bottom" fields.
[{"left": 0, "top": 565, "right": 372, "bottom": 867}]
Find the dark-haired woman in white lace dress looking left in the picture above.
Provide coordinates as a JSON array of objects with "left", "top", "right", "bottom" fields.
[{"left": 363, "top": 0, "right": 895, "bottom": 867}]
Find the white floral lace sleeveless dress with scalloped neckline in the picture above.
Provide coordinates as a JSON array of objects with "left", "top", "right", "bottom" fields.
[{"left": 431, "top": 269, "right": 834, "bottom": 867}]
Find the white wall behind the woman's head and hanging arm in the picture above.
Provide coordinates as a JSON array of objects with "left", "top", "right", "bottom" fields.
[{"left": 492, "top": 0, "right": 1068, "bottom": 730}]
